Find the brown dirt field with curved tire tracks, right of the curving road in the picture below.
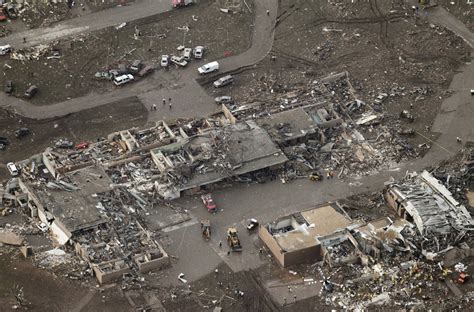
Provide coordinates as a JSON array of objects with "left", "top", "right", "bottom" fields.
[{"left": 208, "top": 0, "right": 470, "bottom": 150}]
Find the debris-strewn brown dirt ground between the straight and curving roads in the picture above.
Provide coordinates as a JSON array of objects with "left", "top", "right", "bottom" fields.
[{"left": 0, "top": 1, "right": 253, "bottom": 105}]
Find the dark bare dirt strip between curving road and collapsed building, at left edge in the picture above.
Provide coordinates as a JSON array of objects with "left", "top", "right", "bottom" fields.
[{"left": 0, "top": 97, "right": 148, "bottom": 180}]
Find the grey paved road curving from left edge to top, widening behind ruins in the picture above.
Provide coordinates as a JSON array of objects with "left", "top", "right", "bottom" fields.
[{"left": 0, "top": 0, "right": 278, "bottom": 121}]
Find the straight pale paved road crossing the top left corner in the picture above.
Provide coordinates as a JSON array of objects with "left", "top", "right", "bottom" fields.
[{"left": 0, "top": 0, "right": 172, "bottom": 48}]
